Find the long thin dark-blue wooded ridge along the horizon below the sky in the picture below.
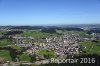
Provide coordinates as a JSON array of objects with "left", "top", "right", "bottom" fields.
[{"left": 11, "top": 26, "right": 82, "bottom": 31}]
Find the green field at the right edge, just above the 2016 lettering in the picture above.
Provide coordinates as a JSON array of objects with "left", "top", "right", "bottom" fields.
[{"left": 81, "top": 41, "right": 100, "bottom": 55}]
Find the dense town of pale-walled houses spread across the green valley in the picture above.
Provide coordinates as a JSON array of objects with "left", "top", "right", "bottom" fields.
[{"left": 13, "top": 33, "right": 80, "bottom": 58}]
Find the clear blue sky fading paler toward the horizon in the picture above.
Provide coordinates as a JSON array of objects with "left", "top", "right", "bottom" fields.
[{"left": 0, "top": 0, "right": 100, "bottom": 25}]
